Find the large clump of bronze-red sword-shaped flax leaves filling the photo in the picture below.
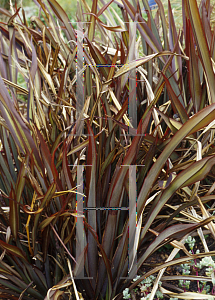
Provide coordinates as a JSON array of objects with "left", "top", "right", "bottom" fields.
[{"left": 0, "top": 0, "right": 215, "bottom": 299}]
